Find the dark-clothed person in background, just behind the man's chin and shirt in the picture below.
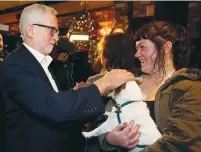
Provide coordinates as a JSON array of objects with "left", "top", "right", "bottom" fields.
[{"left": 50, "top": 37, "right": 95, "bottom": 91}]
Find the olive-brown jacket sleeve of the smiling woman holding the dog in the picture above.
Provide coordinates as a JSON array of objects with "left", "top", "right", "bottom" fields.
[{"left": 142, "top": 80, "right": 201, "bottom": 152}]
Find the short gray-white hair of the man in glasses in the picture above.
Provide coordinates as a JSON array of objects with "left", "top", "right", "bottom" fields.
[{"left": 20, "top": 4, "right": 58, "bottom": 38}]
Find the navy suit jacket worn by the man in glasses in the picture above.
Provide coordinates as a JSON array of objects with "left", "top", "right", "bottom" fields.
[{"left": 0, "top": 45, "right": 104, "bottom": 152}]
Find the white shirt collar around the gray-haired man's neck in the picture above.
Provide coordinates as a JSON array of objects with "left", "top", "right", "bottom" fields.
[{"left": 23, "top": 43, "right": 53, "bottom": 67}]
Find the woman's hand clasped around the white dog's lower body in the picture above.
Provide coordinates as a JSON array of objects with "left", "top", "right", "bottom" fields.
[{"left": 106, "top": 121, "right": 140, "bottom": 149}]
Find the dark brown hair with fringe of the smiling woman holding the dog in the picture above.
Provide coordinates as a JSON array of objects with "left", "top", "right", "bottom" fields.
[{"left": 133, "top": 21, "right": 189, "bottom": 76}]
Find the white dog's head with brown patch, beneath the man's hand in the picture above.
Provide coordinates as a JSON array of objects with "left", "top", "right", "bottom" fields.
[{"left": 108, "top": 81, "right": 143, "bottom": 104}]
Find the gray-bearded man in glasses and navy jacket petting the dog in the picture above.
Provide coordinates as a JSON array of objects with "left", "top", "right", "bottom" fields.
[{"left": 0, "top": 4, "right": 138, "bottom": 152}]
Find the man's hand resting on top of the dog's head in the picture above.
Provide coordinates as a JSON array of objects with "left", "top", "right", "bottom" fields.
[{"left": 94, "top": 69, "right": 135, "bottom": 95}]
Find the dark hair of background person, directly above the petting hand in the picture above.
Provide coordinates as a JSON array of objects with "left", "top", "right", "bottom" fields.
[{"left": 102, "top": 33, "right": 135, "bottom": 72}]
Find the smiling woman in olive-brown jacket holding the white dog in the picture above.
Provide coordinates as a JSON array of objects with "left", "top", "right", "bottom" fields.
[{"left": 100, "top": 21, "right": 201, "bottom": 152}]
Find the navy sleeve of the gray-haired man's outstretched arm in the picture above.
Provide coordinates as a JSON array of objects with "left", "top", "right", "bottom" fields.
[{"left": 0, "top": 64, "right": 104, "bottom": 121}]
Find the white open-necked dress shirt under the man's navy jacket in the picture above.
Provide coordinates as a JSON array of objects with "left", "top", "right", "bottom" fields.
[{"left": 23, "top": 43, "right": 59, "bottom": 92}]
